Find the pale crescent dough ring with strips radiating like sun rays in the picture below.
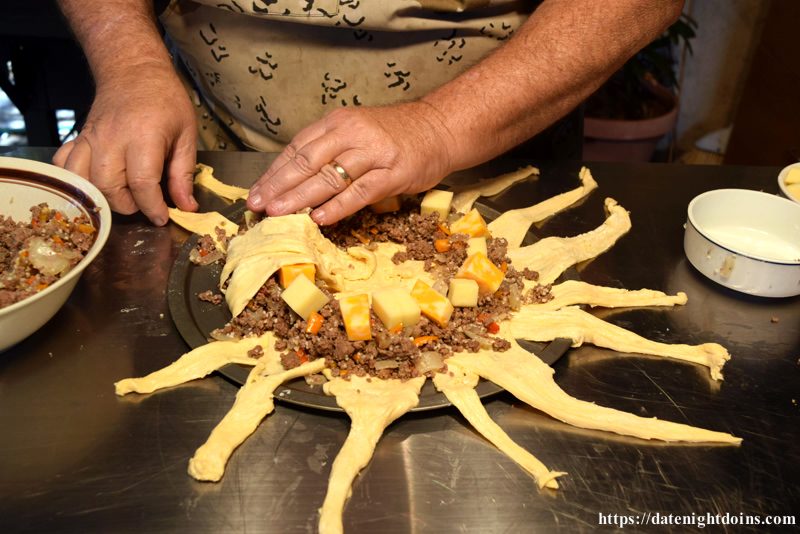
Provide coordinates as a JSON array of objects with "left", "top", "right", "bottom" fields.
[{"left": 116, "top": 167, "right": 741, "bottom": 534}]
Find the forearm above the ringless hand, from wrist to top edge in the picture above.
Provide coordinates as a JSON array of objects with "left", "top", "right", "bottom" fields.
[{"left": 58, "top": 0, "right": 171, "bottom": 87}]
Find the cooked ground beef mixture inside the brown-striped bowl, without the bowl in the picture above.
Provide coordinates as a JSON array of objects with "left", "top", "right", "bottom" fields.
[{"left": 0, "top": 204, "right": 97, "bottom": 308}]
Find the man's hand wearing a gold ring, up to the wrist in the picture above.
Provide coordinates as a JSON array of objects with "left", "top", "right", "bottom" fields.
[{"left": 247, "top": 102, "right": 455, "bottom": 225}]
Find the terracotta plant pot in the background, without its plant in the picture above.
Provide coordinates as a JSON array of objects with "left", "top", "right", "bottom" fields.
[{"left": 583, "top": 84, "right": 678, "bottom": 161}]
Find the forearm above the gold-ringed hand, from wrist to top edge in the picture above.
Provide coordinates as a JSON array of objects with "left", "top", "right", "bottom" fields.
[{"left": 422, "top": 0, "right": 683, "bottom": 170}]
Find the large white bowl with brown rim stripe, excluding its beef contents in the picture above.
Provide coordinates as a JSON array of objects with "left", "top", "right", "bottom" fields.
[{"left": 0, "top": 157, "right": 111, "bottom": 351}]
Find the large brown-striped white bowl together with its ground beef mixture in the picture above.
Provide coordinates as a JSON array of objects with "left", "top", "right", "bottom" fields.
[{"left": 0, "top": 157, "right": 111, "bottom": 351}]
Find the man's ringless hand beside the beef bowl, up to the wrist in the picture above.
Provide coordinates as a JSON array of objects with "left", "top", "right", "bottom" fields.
[{"left": 53, "top": 65, "right": 197, "bottom": 226}]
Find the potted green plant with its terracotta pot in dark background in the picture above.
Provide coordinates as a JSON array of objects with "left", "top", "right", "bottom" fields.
[{"left": 583, "top": 13, "right": 697, "bottom": 161}]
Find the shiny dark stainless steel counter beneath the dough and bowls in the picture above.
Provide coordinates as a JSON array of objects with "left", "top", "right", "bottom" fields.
[{"left": 0, "top": 149, "right": 800, "bottom": 533}]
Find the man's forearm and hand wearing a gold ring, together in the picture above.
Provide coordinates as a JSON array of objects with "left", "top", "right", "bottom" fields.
[{"left": 247, "top": 0, "right": 683, "bottom": 224}]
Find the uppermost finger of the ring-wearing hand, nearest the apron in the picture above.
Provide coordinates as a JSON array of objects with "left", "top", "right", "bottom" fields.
[{"left": 248, "top": 127, "right": 349, "bottom": 210}]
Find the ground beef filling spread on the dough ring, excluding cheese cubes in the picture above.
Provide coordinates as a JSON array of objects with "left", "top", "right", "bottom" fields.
[{"left": 196, "top": 202, "right": 553, "bottom": 379}]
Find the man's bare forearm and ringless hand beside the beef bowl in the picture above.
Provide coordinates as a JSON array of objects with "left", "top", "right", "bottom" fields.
[{"left": 53, "top": 0, "right": 197, "bottom": 225}]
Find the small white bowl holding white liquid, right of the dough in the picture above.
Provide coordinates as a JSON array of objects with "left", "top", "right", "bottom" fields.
[{"left": 683, "top": 189, "right": 800, "bottom": 297}]
